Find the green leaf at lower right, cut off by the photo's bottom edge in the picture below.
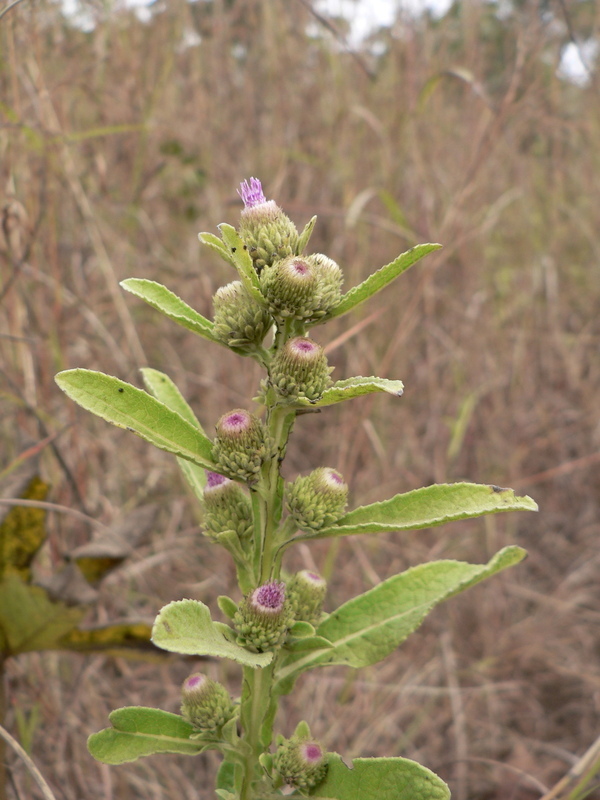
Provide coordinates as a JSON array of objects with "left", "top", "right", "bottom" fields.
[{"left": 311, "top": 753, "right": 450, "bottom": 800}]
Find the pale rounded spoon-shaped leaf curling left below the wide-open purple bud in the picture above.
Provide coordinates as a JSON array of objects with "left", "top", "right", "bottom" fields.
[{"left": 152, "top": 600, "right": 273, "bottom": 667}]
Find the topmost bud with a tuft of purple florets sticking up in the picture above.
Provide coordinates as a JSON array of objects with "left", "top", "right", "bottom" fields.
[{"left": 238, "top": 178, "right": 298, "bottom": 272}]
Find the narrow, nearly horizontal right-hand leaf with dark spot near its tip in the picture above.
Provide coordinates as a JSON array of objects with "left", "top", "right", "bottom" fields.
[{"left": 304, "top": 483, "right": 538, "bottom": 541}]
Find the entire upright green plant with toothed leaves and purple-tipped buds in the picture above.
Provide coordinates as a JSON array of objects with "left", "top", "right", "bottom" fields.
[{"left": 56, "top": 178, "right": 536, "bottom": 800}]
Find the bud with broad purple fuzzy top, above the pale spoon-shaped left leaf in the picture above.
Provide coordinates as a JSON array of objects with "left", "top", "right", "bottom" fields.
[{"left": 233, "top": 581, "right": 294, "bottom": 652}]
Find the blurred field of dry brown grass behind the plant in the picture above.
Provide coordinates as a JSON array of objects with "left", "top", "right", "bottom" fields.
[{"left": 0, "top": 0, "right": 600, "bottom": 800}]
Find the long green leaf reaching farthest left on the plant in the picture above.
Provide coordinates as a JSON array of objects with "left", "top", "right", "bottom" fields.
[{"left": 55, "top": 369, "right": 215, "bottom": 470}]
